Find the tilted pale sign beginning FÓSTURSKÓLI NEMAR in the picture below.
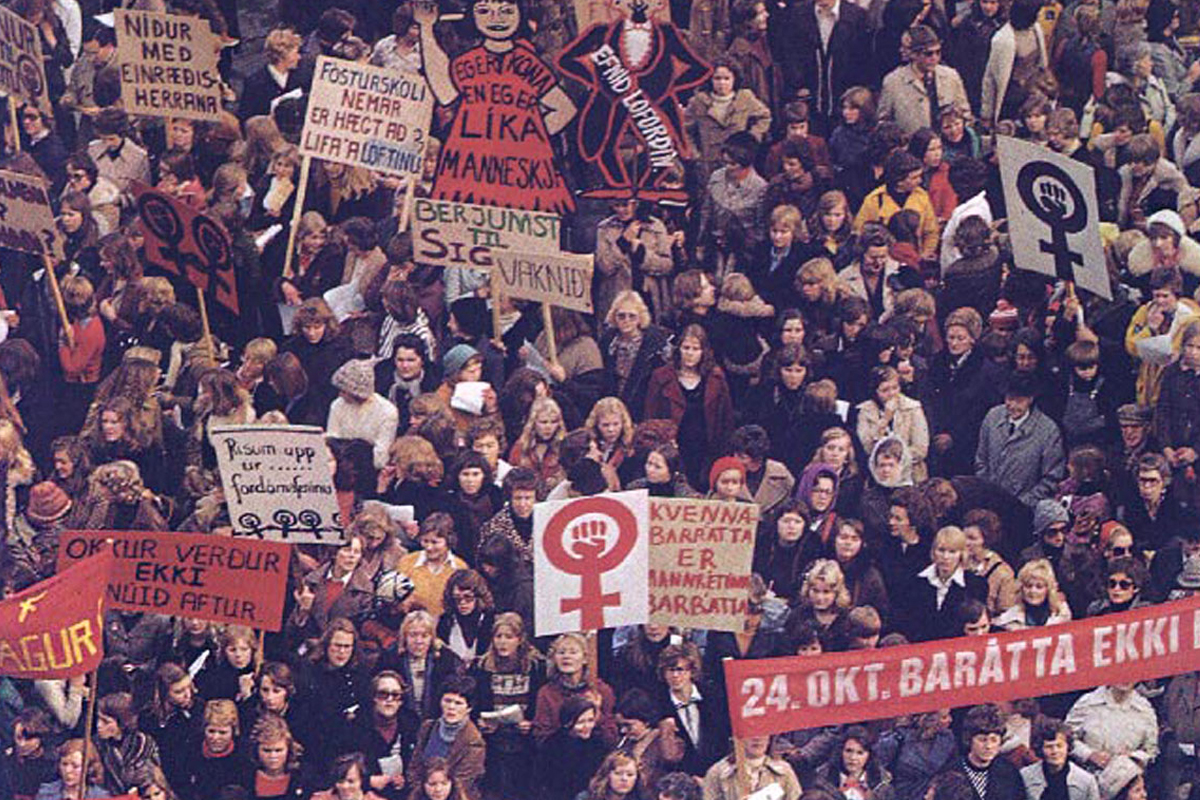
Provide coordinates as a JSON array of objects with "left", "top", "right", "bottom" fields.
[{"left": 300, "top": 55, "right": 433, "bottom": 175}]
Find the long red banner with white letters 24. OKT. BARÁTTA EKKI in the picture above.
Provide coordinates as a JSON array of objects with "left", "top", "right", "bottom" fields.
[{"left": 725, "top": 595, "right": 1200, "bottom": 736}]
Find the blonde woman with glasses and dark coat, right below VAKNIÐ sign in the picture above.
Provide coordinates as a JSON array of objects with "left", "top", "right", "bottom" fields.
[{"left": 600, "top": 289, "right": 671, "bottom": 422}]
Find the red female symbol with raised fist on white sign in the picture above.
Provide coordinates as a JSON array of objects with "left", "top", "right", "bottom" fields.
[{"left": 542, "top": 498, "right": 637, "bottom": 631}]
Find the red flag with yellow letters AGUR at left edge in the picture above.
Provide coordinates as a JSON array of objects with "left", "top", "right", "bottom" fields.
[{"left": 0, "top": 552, "right": 113, "bottom": 680}]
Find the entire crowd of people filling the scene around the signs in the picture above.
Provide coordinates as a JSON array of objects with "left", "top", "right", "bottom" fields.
[{"left": 0, "top": 0, "right": 1200, "bottom": 800}]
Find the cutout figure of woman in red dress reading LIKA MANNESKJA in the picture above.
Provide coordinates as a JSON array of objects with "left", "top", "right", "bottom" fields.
[{"left": 413, "top": 0, "right": 576, "bottom": 213}]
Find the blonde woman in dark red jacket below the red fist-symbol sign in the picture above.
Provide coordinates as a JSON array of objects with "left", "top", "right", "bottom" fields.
[{"left": 533, "top": 633, "right": 617, "bottom": 745}]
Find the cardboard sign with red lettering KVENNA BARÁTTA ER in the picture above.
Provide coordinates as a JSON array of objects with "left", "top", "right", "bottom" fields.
[{"left": 650, "top": 498, "right": 758, "bottom": 633}]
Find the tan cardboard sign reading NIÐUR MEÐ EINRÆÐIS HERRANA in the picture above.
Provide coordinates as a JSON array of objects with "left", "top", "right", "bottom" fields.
[{"left": 113, "top": 8, "right": 222, "bottom": 120}]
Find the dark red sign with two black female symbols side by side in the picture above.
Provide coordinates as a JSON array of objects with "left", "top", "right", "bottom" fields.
[{"left": 133, "top": 184, "right": 239, "bottom": 314}]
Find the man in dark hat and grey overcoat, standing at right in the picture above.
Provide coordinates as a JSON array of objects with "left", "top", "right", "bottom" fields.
[{"left": 976, "top": 375, "right": 1067, "bottom": 507}]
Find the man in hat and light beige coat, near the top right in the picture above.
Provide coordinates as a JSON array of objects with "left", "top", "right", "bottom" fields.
[{"left": 880, "top": 25, "right": 971, "bottom": 138}]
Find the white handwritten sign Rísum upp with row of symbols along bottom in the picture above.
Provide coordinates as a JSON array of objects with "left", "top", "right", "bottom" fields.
[{"left": 210, "top": 425, "right": 346, "bottom": 545}]
